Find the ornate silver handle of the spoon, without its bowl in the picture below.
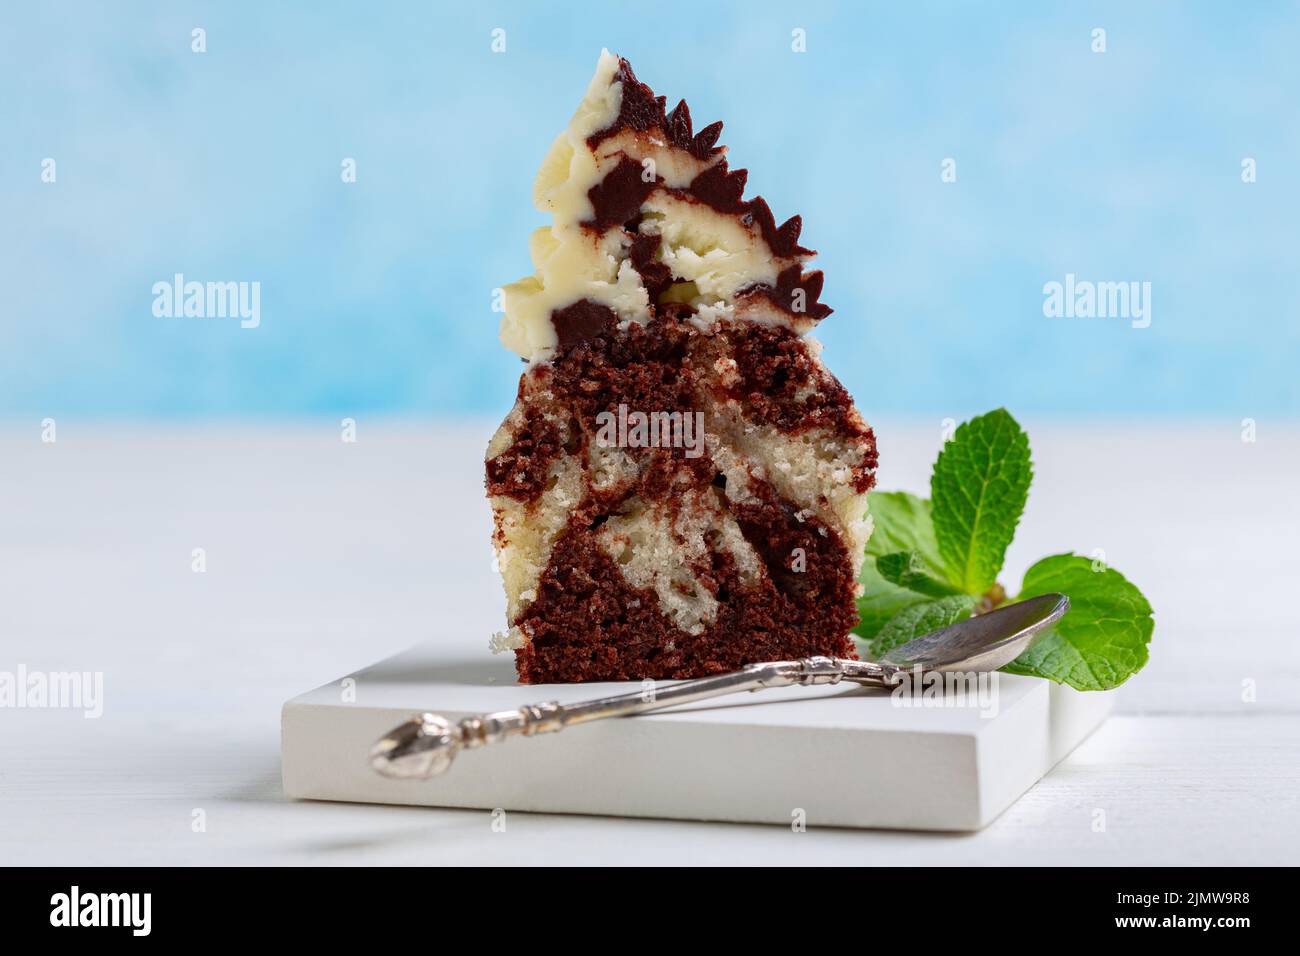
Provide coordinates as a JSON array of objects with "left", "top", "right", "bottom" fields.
[{"left": 371, "top": 657, "right": 897, "bottom": 779}]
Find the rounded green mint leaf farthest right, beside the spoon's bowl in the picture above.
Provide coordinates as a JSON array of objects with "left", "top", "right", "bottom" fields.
[{"left": 1004, "top": 554, "right": 1156, "bottom": 691}]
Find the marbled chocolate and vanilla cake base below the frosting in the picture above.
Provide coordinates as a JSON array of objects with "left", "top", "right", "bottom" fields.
[{"left": 488, "top": 311, "right": 876, "bottom": 683}]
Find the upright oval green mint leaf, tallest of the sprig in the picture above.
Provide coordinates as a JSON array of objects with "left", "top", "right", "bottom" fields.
[{"left": 930, "top": 408, "right": 1032, "bottom": 594}]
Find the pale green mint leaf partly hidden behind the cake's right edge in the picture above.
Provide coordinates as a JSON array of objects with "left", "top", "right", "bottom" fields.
[{"left": 853, "top": 492, "right": 943, "bottom": 640}]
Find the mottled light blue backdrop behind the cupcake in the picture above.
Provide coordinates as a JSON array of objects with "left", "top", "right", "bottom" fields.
[{"left": 0, "top": 1, "right": 1300, "bottom": 419}]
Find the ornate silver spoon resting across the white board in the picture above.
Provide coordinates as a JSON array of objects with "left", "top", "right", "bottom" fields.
[{"left": 371, "top": 594, "right": 1070, "bottom": 779}]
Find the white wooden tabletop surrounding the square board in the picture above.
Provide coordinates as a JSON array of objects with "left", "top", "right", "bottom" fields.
[{"left": 0, "top": 418, "right": 1300, "bottom": 865}]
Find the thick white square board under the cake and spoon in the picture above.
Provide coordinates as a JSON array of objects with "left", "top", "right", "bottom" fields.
[{"left": 281, "top": 644, "right": 1113, "bottom": 830}]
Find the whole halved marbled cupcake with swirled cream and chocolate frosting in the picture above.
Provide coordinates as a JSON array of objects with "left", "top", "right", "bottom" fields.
[{"left": 486, "top": 52, "right": 876, "bottom": 683}]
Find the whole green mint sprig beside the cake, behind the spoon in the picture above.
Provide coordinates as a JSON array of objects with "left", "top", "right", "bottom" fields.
[{"left": 854, "top": 408, "right": 1154, "bottom": 691}]
